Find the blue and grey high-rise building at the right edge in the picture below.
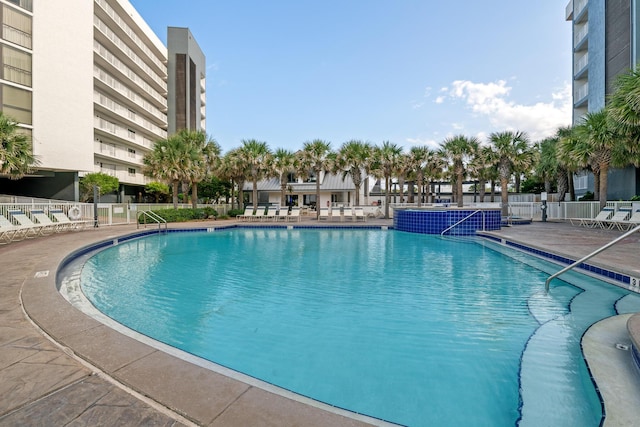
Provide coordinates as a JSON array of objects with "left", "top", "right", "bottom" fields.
[{"left": 566, "top": 0, "right": 640, "bottom": 200}]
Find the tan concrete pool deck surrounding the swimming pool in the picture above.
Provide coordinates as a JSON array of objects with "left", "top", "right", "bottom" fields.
[{"left": 0, "top": 219, "right": 640, "bottom": 426}]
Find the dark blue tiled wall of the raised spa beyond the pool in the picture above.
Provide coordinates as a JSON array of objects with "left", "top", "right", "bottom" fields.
[{"left": 393, "top": 209, "right": 501, "bottom": 236}]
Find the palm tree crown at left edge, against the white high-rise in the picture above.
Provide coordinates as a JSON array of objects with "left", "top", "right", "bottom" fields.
[{"left": 0, "top": 111, "right": 40, "bottom": 179}]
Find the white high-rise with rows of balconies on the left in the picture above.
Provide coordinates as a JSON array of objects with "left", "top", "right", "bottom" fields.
[{"left": 0, "top": 0, "right": 205, "bottom": 202}]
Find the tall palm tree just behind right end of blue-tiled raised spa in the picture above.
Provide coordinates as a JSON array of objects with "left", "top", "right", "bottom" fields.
[{"left": 489, "top": 131, "right": 530, "bottom": 216}]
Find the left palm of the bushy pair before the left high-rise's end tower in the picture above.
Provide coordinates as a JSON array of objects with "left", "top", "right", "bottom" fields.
[{"left": 142, "top": 135, "right": 190, "bottom": 209}]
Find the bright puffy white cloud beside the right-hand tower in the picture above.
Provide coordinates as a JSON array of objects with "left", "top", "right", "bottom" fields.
[{"left": 447, "top": 80, "right": 572, "bottom": 141}]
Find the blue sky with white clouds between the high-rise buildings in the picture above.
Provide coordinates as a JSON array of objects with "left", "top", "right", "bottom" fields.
[{"left": 130, "top": 0, "right": 572, "bottom": 153}]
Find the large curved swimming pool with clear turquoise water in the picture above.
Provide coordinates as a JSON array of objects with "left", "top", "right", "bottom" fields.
[{"left": 81, "top": 228, "right": 640, "bottom": 426}]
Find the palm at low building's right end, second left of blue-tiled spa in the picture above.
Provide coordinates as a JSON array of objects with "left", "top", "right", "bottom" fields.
[{"left": 333, "top": 140, "right": 373, "bottom": 206}]
